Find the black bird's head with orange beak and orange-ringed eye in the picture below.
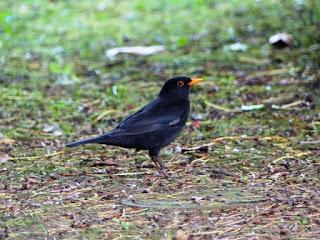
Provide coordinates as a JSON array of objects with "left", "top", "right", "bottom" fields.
[{"left": 159, "top": 77, "right": 203, "bottom": 100}]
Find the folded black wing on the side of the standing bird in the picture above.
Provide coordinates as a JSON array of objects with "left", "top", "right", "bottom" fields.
[{"left": 110, "top": 101, "right": 184, "bottom": 137}]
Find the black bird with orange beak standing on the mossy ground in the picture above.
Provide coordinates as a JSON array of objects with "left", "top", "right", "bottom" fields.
[{"left": 66, "top": 77, "right": 202, "bottom": 175}]
